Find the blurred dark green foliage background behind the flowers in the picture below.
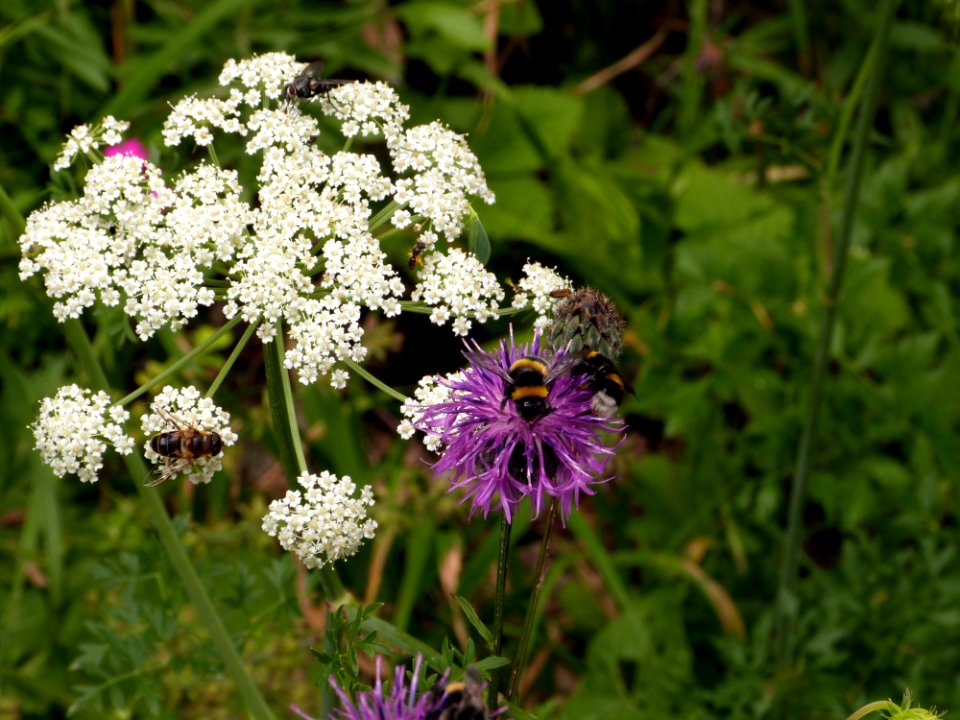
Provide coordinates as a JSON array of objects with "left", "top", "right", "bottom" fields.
[{"left": 0, "top": 0, "right": 960, "bottom": 719}]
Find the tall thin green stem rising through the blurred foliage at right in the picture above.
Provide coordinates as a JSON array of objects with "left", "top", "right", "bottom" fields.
[{"left": 774, "top": 0, "right": 896, "bottom": 667}]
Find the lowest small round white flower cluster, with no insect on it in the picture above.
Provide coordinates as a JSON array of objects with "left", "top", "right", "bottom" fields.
[{"left": 263, "top": 471, "right": 377, "bottom": 568}]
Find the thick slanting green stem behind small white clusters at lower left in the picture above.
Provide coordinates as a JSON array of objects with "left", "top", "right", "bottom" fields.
[{"left": 64, "top": 319, "right": 273, "bottom": 720}]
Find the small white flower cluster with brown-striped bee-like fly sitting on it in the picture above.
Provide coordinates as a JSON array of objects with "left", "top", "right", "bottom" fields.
[{"left": 140, "top": 385, "right": 237, "bottom": 484}]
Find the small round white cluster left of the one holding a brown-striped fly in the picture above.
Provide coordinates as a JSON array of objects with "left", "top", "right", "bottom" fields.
[{"left": 32, "top": 385, "right": 133, "bottom": 482}]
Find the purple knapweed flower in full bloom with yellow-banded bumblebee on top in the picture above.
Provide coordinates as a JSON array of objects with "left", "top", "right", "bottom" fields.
[{"left": 415, "top": 332, "right": 623, "bottom": 522}]
